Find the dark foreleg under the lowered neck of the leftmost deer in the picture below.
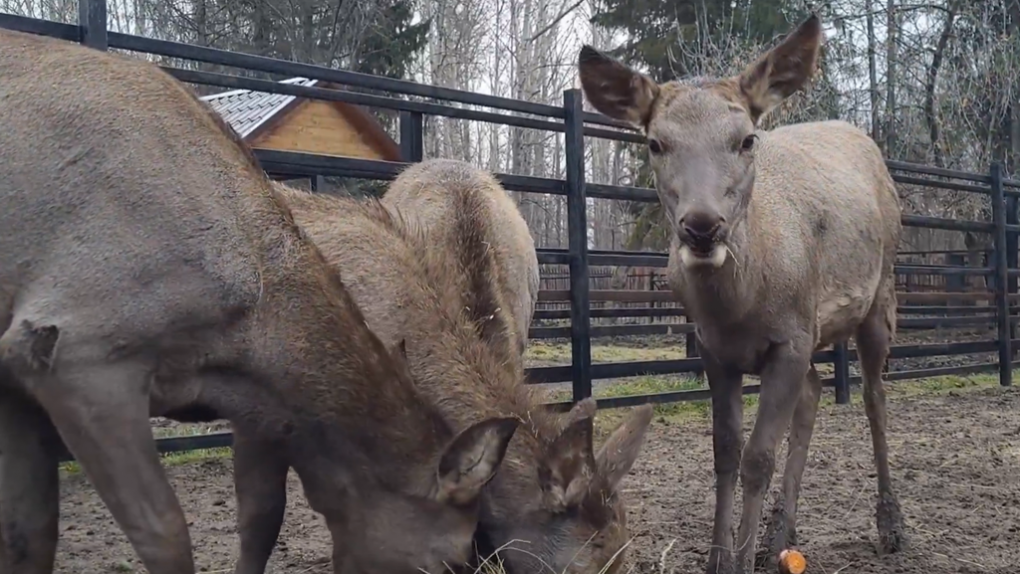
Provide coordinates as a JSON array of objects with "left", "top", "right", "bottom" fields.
[{"left": 234, "top": 427, "right": 290, "bottom": 574}]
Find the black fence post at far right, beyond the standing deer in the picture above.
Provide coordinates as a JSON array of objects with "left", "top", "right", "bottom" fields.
[{"left": 991, "top": 162, "right": 1013, "bottom": 386}]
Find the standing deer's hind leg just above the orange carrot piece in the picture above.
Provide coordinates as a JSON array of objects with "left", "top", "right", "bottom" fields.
[{"left": 765, "top": 365, "right": 822, "bottom": 567}]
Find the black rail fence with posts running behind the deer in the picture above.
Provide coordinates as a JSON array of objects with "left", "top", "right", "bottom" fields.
[{"left": 7, "top": 0, "right": 1020, "bottom": 458}]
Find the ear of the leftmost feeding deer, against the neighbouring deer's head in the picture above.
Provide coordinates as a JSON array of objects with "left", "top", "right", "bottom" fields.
[{"left": 435, "top": 418, "right": 519, "bottom": 506}]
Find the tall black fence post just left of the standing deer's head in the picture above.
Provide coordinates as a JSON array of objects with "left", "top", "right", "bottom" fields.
[{"left": 563, "top": 89, "right": 592, "bottom": 402}]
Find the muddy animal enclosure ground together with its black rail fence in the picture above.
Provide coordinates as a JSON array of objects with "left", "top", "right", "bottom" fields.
[{"left": 0, "top": 0, "right": 1020, "bottom": 574}]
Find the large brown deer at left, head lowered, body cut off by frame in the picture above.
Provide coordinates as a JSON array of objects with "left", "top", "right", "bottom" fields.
[{"left": 0, "top": 31, "right": 517, "bottom": 574}]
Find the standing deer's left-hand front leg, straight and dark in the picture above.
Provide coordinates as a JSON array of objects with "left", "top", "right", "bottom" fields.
[{"left": 704, "top": 354, "right": 744, "bottom": 574}]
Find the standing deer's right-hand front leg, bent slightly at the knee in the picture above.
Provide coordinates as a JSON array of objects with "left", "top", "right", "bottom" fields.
[{"left": 736, "top": 343, "right": 811, "bottom": 574}]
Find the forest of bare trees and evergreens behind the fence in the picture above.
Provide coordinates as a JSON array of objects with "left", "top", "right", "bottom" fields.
[{"left": 7, "top": 0, "right": 1020, "bottom": 251}]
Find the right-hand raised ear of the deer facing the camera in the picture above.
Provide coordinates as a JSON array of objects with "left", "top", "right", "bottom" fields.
[{"left": 737, "top": 14, "right": 822, "bottom": 123}]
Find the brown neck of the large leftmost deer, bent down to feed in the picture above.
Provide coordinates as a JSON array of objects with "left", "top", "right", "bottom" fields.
[{"left": 240, "top": 245, "right": 451, "bottom": 481}]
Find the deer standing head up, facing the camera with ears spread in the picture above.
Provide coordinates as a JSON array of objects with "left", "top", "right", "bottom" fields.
[{"left": 578, "top": 15, "right": 905, "bottom": 573}]
